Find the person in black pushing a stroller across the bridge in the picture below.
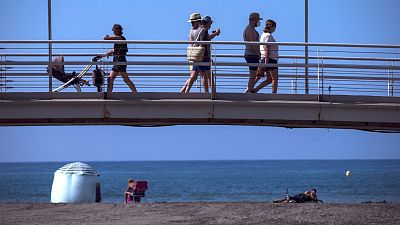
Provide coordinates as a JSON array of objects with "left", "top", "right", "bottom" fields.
[{"left": 99, "top": 24, "right": 137, "bottom": 94}]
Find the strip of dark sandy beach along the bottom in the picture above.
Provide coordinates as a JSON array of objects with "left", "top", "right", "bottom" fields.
[{"left": 0, "top": 202, "right": 400, "bottom": 225}]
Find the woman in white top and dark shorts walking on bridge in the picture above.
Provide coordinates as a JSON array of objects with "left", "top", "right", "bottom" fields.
[{"left": 253, "top": 20, "right": 279, "bottom": 93}]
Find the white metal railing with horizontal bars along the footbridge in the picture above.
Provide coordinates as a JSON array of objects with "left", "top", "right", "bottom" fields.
[{"left": 0, "top": 40, "right": 400, "bottom": 96}]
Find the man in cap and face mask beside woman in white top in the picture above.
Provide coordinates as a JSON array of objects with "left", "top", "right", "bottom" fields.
[{"left": 243, "top": 12, "right": 263, "bottom": 93}]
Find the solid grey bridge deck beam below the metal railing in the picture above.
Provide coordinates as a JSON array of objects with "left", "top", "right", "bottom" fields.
[{"left": 0, "top": 93, "right": 400, "bottom": 131}]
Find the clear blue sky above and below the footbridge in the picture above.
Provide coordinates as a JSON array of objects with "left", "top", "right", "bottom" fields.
[{"left": 0, "top": 0, "right": 400, "bottom": 161}]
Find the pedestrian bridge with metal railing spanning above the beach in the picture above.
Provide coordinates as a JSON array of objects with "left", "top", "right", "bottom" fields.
[{"left": 0, "top": 41, "right": 400, "bottom": 131}]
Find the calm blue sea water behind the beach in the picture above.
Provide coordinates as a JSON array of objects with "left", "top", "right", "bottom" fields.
[{"left": 0, "top": 160, "right": 400, "bottom": 203}]
